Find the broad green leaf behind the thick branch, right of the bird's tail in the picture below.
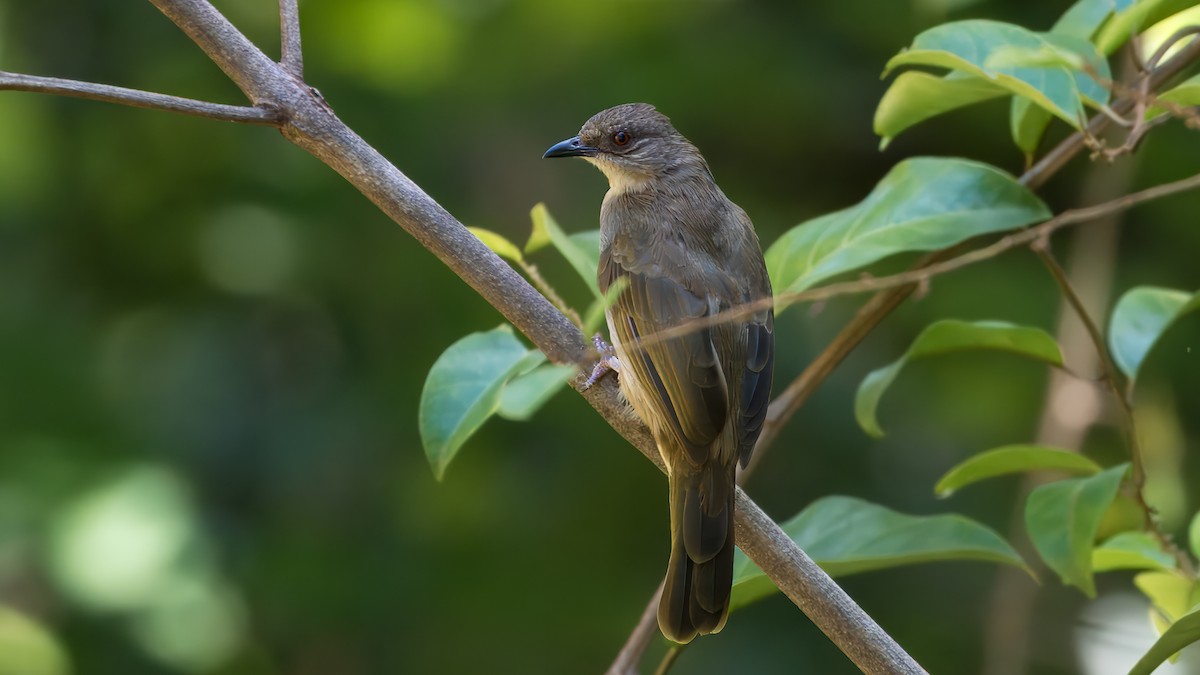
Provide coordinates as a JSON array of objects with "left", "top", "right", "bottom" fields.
[{"left": 730, "top": 496, "right": 1032, "bottom": 608}]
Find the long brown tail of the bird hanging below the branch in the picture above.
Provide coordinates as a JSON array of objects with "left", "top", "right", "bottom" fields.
[{"left": 659, "top": 461, "right": 736, "bottom": 643}]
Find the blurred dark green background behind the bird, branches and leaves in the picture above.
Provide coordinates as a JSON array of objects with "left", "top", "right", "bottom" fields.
[{"left": 0, "top": 0, "right": 1200, "bottom": 675}]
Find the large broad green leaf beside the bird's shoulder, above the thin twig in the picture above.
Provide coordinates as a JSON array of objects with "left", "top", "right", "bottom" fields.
[{"left": 767, "top": 157, "right": 1050, "bottom": 293}]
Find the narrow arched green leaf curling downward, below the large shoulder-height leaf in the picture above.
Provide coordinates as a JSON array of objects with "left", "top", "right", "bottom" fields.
[{"left": 854, "top": 319, "right": 1062, "bottom": 438}]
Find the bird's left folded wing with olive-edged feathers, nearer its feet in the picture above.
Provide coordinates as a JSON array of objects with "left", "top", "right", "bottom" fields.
[{"left": 599, "top": 243, "right": 728, "bottom": 466}]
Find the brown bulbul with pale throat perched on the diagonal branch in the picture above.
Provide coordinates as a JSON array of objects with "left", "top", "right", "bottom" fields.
[{"left": 545, "top": 103, "right": 775, "bottom": 643}]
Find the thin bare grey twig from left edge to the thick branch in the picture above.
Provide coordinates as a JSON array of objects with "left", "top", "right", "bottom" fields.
[{"left": 0, "top": 71, "right": 283, "bottom": 126}]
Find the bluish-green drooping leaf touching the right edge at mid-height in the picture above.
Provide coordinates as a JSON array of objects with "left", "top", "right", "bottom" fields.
[{"left": 1109, "top": 286, "right": 1200, "bottom": 381}]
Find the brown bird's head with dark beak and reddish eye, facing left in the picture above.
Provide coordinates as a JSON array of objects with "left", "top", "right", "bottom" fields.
[{"left": 542, "top": 103, "right": 708, "bottom": 192}]
